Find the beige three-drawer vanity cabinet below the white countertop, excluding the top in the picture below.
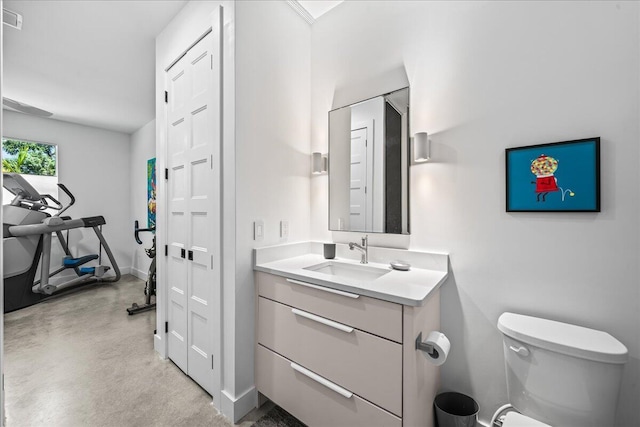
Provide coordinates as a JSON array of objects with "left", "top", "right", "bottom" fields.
[{"left": 255, "top": 272, "right": 440, "bottom": 427}]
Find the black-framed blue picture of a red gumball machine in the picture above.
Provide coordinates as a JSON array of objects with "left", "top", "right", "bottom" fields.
[{"left": 505, "top": 137, "right": 600, "bottom": 212}]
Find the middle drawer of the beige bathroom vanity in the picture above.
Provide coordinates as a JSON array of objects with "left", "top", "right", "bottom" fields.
[{"left": 258, "top": 297, "right": 402, "bottom": 416}]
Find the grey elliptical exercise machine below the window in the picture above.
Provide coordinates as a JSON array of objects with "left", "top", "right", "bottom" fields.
[{"left": 2, "top": 173, "right": 120, "bottom": 313}]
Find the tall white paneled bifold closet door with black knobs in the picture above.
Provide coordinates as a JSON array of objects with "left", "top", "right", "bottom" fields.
[{"left": 167, "top": 27, "right": 221, "bottom": 401}]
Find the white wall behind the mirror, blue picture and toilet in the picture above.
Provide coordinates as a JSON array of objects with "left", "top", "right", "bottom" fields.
[{"left": 311, "top": 1, "right": 640, "bottom": 426}]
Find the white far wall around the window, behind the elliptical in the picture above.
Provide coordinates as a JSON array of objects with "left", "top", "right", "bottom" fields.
[{"left": 2, "top": 110, "right": 132, "bottom": 274}]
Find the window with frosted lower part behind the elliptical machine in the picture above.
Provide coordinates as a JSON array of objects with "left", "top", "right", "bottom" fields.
[{"left": 2, "top": 138, "right": 58, "bottom": 204}]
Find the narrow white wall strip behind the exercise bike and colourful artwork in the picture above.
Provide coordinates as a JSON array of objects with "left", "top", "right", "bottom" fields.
[{"left": 128, "top": 120, "right": 155, "bottom": 280}]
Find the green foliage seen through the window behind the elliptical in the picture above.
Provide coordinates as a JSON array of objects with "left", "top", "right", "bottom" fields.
[{"left": 2, "top": 138, "right": 56, "bottom": 176}]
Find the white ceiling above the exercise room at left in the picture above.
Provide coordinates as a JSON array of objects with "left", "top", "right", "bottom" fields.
[{"left": 2, "top": 0, "right": 187, "bottom": 133}]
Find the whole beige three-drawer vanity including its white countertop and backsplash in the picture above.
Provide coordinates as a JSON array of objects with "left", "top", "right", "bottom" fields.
[{"left": 255, "top": 242, "right": 448, "bottom": 427}]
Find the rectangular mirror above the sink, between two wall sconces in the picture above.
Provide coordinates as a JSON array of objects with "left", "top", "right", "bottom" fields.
[{"left": 329, "top": 87, "right": 410, "bottom": 234}]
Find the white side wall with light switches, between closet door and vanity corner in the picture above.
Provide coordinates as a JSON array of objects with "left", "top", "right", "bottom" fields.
[{"left": 235, "top": 1, "right": 312, "bottom": 414}]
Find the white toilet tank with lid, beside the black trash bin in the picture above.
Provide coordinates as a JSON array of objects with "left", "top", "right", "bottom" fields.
[{"left": 498, "top": 313, "right": 628, "bottom": 427}]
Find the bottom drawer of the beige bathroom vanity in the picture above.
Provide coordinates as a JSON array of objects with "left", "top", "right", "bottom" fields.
[{"left": 256, "top": 345, "right": 402, "bottom": 427}]
